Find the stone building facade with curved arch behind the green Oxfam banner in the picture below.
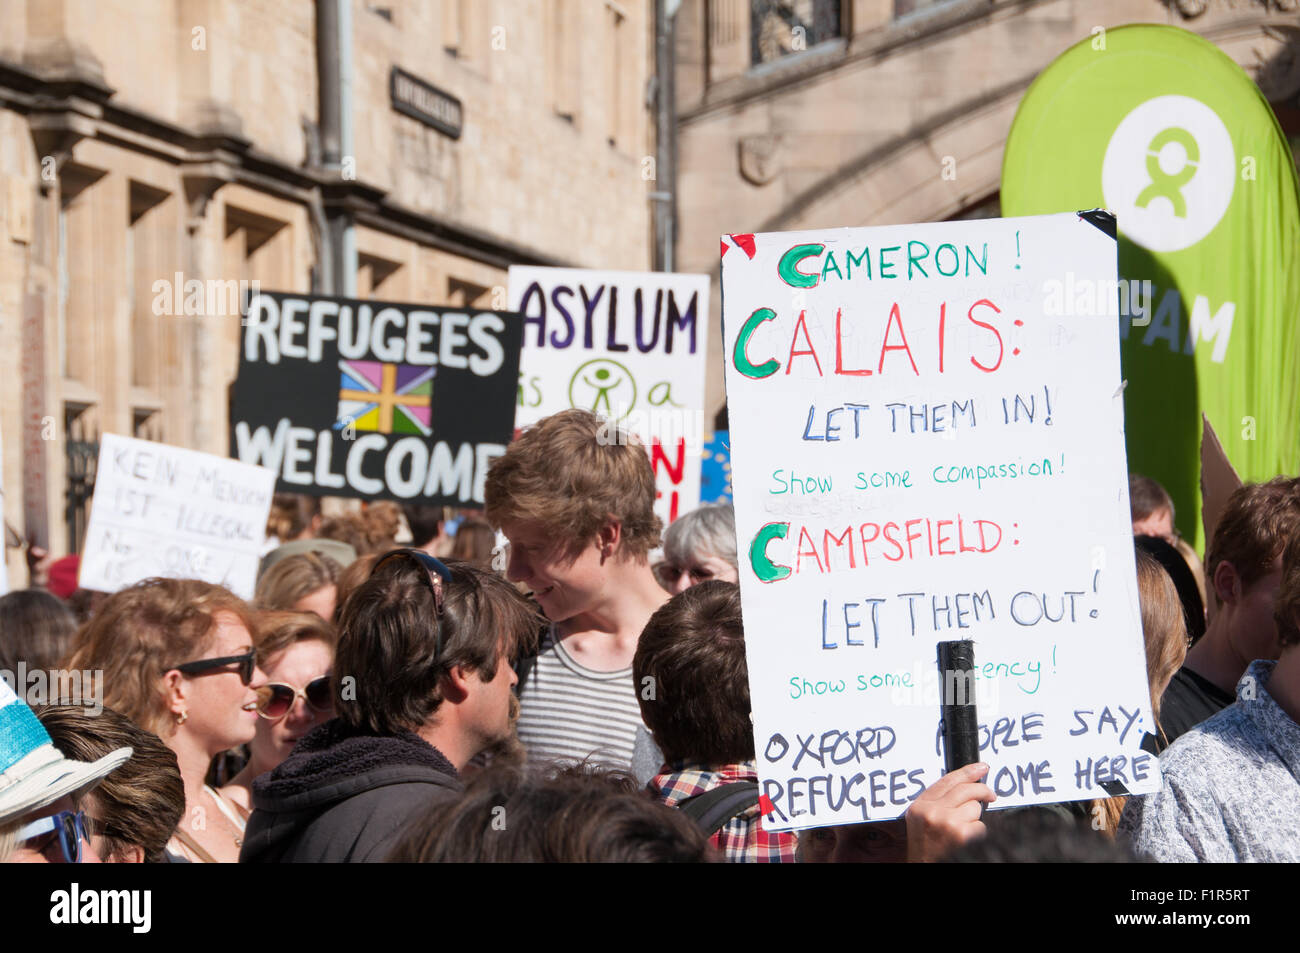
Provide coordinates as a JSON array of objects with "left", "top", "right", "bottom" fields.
[{"left": 675, "top": 0, "right": 1300, "bottom": 412}]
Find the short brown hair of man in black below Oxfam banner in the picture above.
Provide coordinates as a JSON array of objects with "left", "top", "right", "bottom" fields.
[{"left": 1205, "top": 477, "right": 1300, "bottom": 605}]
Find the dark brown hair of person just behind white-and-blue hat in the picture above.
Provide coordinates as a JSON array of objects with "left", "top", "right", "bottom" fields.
[{"left": 35, "top": 705, "right": 185, "bottom": 863}]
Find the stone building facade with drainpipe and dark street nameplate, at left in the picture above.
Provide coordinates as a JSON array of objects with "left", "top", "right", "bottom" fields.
[{"left": 0, "top": 0, "right": 655, "bottom": 585}]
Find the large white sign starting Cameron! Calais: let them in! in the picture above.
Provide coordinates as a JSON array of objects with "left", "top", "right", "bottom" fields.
[{"left": 723, "top": 215, "right": 1158, "bottom": 829}]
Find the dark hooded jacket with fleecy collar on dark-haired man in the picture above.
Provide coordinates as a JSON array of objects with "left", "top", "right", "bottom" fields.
[{"left": 239, "top": 718, "right": 462, "bottom": 863}]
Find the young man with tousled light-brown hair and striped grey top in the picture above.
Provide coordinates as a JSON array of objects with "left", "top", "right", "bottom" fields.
[{"left": 486, "top": 410, "right": 668, "bottom": 771}]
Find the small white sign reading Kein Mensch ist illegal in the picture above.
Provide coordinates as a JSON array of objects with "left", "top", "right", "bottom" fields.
[{"left": 78, "top": 433, "right": 276, "bottom": 599}]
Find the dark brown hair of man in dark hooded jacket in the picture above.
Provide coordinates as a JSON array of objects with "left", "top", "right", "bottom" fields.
[{"left": 334, "top": 559, "right": 540, "bottom": 735}]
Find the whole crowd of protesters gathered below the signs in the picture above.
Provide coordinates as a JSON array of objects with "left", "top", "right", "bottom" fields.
[{"left": 0, "top": 411, "right": 1300, "bottom": 863}]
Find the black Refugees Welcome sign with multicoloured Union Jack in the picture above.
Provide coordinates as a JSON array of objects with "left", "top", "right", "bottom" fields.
[{"left": 230, "top": 294, "right": 523, "bottom": 506}]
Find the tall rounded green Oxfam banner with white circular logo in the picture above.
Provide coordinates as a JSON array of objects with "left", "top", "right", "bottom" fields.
[{"left": 1002, "top": 26, "right": 1300, "bottom": 541}]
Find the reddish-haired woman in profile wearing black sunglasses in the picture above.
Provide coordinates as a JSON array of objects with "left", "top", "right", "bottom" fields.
[{"left": 65, "top": 579, "right": 265, "bottom": 863}]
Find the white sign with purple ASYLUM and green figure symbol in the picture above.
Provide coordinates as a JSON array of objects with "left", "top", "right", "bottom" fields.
[{"left": 508, "top": 267, "right": 709, "bottom": 524}]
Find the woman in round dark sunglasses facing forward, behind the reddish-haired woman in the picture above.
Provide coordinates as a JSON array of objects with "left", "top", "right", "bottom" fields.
[{"left": 221, "top": 612, "right": 338, "bottom": 818}]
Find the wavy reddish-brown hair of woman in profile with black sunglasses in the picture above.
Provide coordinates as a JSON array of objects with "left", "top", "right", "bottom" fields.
[{"left": 65, "top": 579, "right": 257, "bottom": 735}]
